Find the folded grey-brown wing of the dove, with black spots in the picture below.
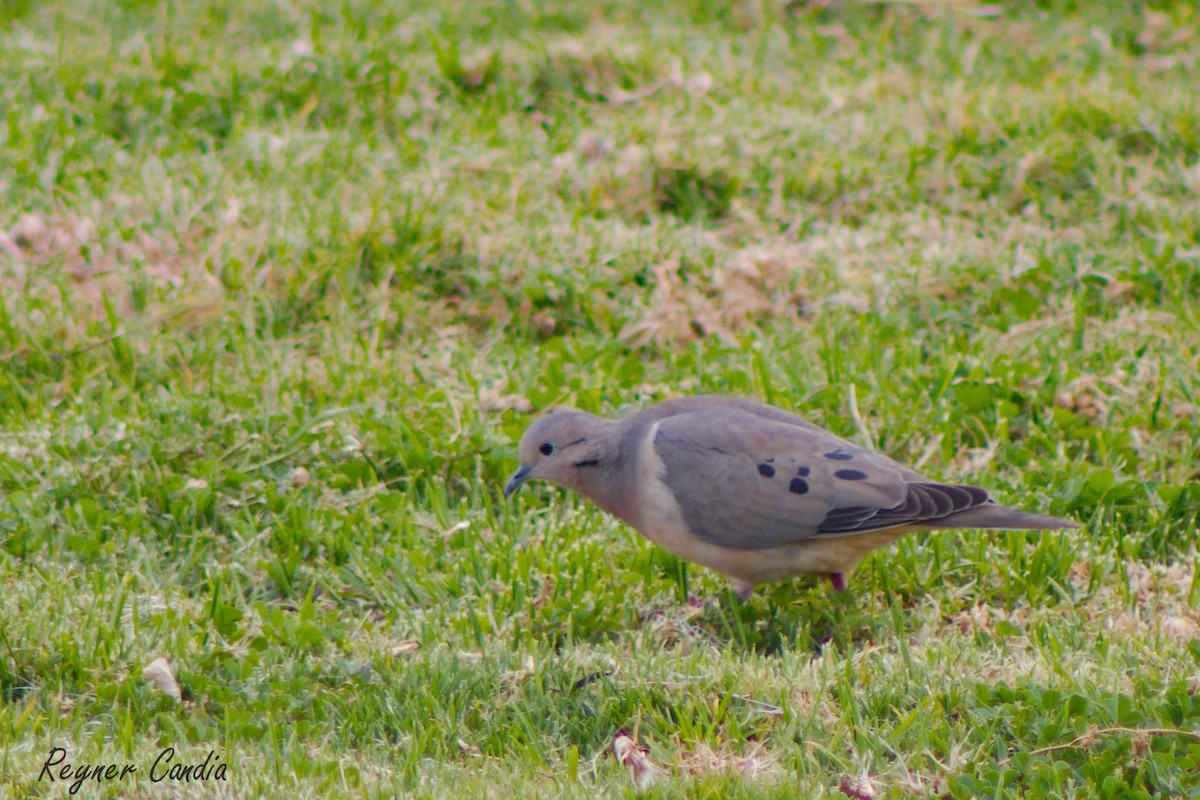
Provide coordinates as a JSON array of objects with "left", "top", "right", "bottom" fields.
[{"left": 654, "top": 409, "right": 988, "bottom": 549}]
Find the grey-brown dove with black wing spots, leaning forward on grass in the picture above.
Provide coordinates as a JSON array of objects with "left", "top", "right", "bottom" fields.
[{"left": 504, "top": 395, "right": 1079, "bottom": 600}]
